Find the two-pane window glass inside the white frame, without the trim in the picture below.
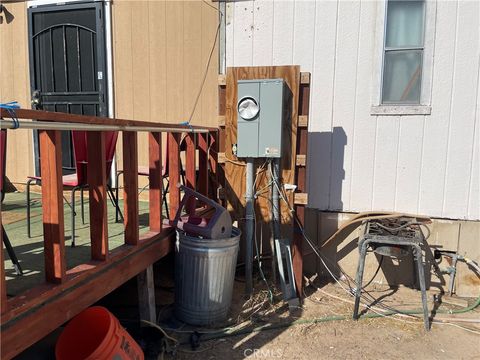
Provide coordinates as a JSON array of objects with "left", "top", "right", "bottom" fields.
[{"left": 382, "top": 0, "right": 425, "bottom": 104}]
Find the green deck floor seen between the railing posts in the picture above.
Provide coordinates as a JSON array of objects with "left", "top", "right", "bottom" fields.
[{"left": 2, "top": 192, "right": 154, "bottom": 297}]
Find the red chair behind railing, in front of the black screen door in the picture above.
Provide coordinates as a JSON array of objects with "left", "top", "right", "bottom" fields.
[{"left": 27, "top": 131, "right": 120, "bottom": 246}]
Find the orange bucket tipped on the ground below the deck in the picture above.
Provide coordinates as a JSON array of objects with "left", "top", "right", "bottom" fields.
[{"left": 55, "top": 306, "right": 144, "bottom": 360}]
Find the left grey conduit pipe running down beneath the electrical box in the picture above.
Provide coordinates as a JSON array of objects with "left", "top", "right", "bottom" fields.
[{"left": 245, "top": 158, "right": 255, "bottom": 295}]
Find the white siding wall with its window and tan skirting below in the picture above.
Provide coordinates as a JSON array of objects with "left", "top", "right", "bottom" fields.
[{"left": 225, "top": 0, "right": 480, "bottom": 295}]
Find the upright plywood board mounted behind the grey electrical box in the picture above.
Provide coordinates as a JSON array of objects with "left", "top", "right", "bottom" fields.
[{"left": 225, "top": 66, "right": 300, "bottom": 224}]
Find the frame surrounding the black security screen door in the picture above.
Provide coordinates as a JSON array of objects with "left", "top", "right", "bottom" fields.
[{"left": 27, "top": 0, "right": 108, "bottom": 176}]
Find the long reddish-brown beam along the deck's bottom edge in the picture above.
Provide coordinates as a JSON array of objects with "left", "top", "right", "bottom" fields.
[{"left": 0, "top": 228, "right": 174, "bottom": 359}]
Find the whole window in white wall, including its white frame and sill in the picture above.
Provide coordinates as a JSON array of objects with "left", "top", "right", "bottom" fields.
[{"left": 372, "top": 0, "right": 436, "bottom": 115}]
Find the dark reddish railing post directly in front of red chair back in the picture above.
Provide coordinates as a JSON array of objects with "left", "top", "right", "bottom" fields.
[{"left": 87, "top": 131, "right": 108, "bottom": 260}]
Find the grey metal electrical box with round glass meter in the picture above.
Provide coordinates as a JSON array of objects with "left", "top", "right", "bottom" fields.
[{"left": 237, "top": 79, "right": 289, "bottom": 158}]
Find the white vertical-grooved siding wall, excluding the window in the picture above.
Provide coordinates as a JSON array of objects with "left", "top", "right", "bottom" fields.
[{"left": 226, "top": 0, "right": 480, "bottom": 220}]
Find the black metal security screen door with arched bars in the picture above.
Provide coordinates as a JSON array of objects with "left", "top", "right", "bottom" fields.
[{"left": 28, "top": 3, "right": 107, "bottom": 174}]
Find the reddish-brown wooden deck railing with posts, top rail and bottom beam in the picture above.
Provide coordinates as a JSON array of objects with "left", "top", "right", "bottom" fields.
[{"left": 0, "top": 109, "right": 218, "bottom": 359}]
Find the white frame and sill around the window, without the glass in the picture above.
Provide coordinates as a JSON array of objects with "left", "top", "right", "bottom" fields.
[{"left": 370, "top": 0, "right": 437, "bottom": 115}]
